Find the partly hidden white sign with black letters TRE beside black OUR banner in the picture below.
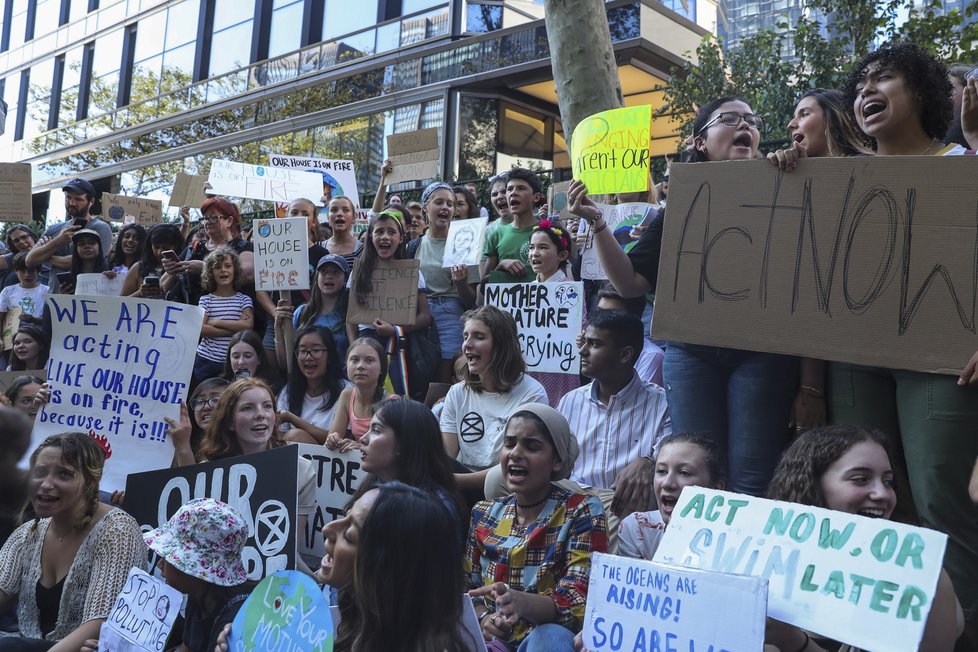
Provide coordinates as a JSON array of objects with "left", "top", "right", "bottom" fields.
[{"left": 298, "top": 444, "right": 366, "bottom": 568}]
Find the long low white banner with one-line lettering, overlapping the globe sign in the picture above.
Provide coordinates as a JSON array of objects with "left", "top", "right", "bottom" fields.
[{"left": 207, "top": 159, "right": 323, "bottom": 202}]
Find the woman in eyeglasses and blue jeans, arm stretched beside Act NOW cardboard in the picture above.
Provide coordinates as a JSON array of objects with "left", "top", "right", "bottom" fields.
[{"left": 568, "top": 97, "right": 799, "bottom": 495}]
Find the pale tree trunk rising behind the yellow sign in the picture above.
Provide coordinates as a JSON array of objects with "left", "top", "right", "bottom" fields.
[{"left": 543, "top": 0, "right": 624, "bottom": 154}]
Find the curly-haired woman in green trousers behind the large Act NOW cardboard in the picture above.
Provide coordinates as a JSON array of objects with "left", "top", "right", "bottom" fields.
[{"left": 828, "top": 44, "right": 978, "bottom": 642}]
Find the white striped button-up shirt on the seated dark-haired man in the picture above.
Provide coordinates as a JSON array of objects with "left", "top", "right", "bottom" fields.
[{"left": 557, "top": 371, "right": 672, "bottom": 489}]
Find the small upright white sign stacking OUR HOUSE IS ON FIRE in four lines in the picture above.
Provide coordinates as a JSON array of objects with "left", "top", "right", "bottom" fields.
[{"left": 252, "top": 217, "right": 309, "bottom": 292}]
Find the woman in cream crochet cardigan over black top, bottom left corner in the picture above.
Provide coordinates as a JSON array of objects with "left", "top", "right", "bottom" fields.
[{"left": 0, "top": 432, "right": 147, "bottom": 652}]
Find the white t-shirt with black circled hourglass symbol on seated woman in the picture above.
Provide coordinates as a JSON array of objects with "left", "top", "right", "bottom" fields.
[{"left": 440, "top": 374, "right": 550, "bottom": 470}]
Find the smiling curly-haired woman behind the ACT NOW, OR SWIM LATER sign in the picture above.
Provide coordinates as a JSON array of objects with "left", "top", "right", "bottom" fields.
[{"left": 765, "top": 426, "right": 963, "bottom": 652}]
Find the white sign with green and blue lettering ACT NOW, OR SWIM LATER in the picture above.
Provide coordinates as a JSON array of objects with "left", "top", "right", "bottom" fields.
[{"left": 655, "top": 487, "right": 947, "bottom": 652}]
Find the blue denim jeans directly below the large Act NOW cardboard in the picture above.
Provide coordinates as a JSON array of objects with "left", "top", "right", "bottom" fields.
[{"left": 663, "top": 342, "right": 799, "bottom": 496}]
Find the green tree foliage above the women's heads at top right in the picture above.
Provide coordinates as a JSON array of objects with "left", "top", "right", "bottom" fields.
[{"left": 658, "top": 0, "right": 978, "bottom": 146}]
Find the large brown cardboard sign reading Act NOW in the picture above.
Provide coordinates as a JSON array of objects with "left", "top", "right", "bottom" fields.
[{"left": 653, "top": 156, "right": 978, "bottom": 374}]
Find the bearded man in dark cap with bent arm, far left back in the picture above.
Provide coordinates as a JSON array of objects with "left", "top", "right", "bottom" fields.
[{"left": 27, "top": 179, "right": 112, "bottom": 278}]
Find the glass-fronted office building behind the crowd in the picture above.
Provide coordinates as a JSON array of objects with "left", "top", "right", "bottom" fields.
[{"left": 0, "top": 0, "right": 716, "bottom": 216}]
